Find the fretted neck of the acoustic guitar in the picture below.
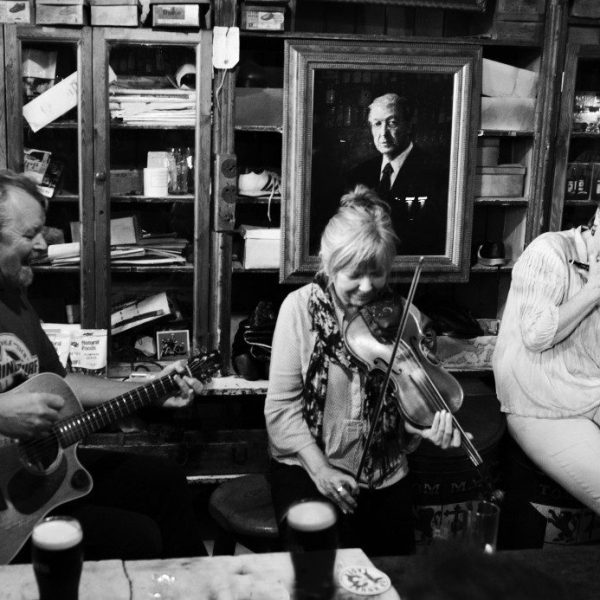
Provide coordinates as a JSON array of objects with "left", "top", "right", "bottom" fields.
[{"left": 53, "top": 373, "right": 177, "bottom": 448}]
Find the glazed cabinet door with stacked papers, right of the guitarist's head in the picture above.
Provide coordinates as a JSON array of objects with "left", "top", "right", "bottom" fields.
[{"left": 88, "top": 27, "right": 211, "bottom": 363}]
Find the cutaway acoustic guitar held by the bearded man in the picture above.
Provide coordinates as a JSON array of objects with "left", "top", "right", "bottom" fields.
[{"left": 0, "top": 352, "right": 220, "bottom": 564}]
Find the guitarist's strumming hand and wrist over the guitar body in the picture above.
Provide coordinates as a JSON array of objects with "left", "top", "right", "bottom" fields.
[{"left": 0, "top": 391, "right": 65, "bottom": 439}]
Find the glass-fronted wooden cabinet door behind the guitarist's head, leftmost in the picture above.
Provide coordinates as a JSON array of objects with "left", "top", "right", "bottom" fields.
[{"left": 4, "top": 25, "right": 99, "bottom": 327}]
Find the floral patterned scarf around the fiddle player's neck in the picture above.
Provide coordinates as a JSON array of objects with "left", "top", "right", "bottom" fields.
[{"left": 302, "top": 276, "right": 408, "bottom": 487}]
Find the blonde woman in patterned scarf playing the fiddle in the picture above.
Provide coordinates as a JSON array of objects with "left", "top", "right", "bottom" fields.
[{"left": 265, "top": 186, "right": 460, "bottom": 554}]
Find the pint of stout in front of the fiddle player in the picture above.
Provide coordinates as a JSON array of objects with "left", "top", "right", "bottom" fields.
[{"left": 285, "top": 500, "right": 337, "bottom": 600}]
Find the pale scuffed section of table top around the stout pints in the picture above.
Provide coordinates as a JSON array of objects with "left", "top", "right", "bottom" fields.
[{"left": 0, "top": 548, "right": 399, "bottom": 600}]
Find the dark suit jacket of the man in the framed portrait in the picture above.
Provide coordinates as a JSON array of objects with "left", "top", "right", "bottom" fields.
[{"left": 346, "top": 144, "right": 448, "bottom": 255}]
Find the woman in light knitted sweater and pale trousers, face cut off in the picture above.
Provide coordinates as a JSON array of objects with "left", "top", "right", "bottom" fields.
[{"left": 493, "top": 213, "right": 600, "bottom": 514}]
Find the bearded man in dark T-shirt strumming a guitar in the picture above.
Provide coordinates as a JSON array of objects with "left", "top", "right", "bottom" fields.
[{"left": 0, "top": 171, "right": 211, "bottom": 562}]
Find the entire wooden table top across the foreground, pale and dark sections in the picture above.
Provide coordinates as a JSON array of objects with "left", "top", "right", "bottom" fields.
[{"left": 0, "top": 546, "right": 600, "bottom": 600}]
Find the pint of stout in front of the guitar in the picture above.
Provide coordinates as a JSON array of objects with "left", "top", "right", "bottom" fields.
[{"left": 31, "top": 516, "right": 83, "bottom": 600}]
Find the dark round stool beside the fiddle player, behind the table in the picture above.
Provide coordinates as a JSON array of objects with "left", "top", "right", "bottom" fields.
[{"left": 208, "top": 474, "right": 281, "bottom": 556}]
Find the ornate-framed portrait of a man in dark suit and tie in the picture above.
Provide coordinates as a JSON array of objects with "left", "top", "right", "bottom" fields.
[{"left": 281, "top": 39, "right": 481, "bottom": 281}]
